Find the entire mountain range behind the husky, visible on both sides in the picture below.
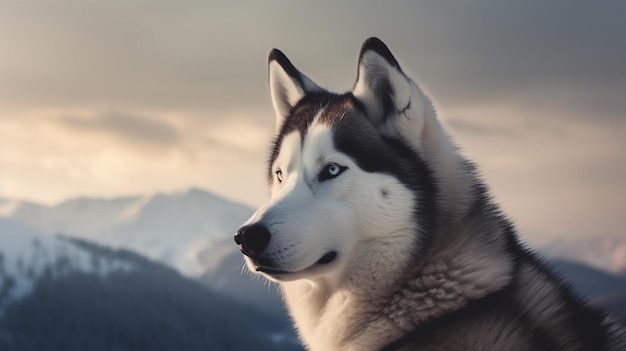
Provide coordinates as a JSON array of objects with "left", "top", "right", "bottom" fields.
[{"left": 0, "top": 188, "right": 626, "bottom": 350}]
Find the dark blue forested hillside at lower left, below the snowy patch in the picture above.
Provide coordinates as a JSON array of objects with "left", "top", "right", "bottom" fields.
[{"left": 0, "top": 240, "right": 300, "bottom": 351}]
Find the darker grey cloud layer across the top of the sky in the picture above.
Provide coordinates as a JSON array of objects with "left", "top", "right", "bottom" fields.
[{"left": 0, "top": 0, "right": 626, "bottom": 125}]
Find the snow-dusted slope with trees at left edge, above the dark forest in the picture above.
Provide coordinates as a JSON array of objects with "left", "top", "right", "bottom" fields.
[{"left": 0, "top": 218, "right": 133, "bottom": 315}]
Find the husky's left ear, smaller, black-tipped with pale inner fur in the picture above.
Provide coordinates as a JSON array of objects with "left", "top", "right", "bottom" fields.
[{"left": 268, "top": 49, "right": 322, "bottom": 131}]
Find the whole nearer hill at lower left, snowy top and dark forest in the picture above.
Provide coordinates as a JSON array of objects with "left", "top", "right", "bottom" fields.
[{"left": 0, "top": 218, "right": 302, "bottom": 351}]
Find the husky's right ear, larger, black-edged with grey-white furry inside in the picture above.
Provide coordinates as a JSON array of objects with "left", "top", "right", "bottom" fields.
[{"left": 352, "top": 38, "right": 434, "bottom": 147}]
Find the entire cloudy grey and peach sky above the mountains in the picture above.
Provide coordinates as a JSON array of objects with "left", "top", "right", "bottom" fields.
[{"left": 0, "top": 0, "right": 626, "bottom": 243}]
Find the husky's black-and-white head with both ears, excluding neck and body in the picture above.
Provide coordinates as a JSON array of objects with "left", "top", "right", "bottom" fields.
[{"left": 235, "top": 38, "right": 435, "bottom": 281}]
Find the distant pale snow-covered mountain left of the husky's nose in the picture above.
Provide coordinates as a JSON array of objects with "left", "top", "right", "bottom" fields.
[{"left": 0, "top": 189, "right": 252, "bottom": 276}]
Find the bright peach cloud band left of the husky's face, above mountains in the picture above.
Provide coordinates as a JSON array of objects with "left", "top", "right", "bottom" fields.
[{"left": 0, "top": 110, "right": 272, "bottom": 204}]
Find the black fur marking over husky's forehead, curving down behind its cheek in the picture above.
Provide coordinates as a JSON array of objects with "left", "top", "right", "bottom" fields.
[{"left": 267, "top": 92, "right": 437, "bottom": 250}]
